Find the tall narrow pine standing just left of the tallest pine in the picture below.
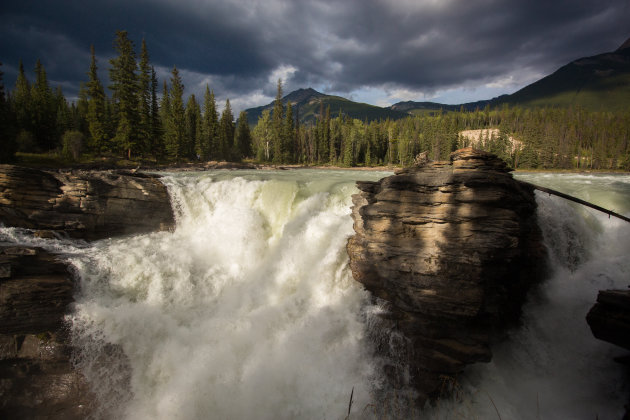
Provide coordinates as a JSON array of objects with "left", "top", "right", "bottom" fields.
[{"left": 86, "top": 45, "right": 109, "bottom": 153}]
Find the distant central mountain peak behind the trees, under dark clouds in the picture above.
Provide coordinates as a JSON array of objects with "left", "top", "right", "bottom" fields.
[{"left": 245, "top": 88, "right": 409, "bottom": 125}]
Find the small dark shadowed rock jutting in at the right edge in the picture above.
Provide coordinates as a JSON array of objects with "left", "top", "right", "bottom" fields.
[{"left": 586, "top": 290, "right": 630, "bottom": 350}]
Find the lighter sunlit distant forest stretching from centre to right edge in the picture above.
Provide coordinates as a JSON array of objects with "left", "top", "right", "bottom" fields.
[{"left": 252, "top": 99, "right": 630, "bottom": 170}]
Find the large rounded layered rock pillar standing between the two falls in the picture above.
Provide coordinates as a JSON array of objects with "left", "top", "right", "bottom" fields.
[{"left": 347, "top": 148, "right": 546, "bottom": 403}]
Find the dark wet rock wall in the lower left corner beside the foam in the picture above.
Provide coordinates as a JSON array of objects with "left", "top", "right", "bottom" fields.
[{"left": 0, "top": 246, "right": 93, "bottom": 420}]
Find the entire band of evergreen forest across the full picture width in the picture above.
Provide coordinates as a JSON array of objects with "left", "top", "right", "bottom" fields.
[{"left": 0, "top": 31, "right": 630, "bottom": 170}]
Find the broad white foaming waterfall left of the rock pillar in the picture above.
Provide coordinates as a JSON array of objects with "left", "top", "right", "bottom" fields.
[{"left": 72, "top": 171, "right": 392, "bottom": 419}]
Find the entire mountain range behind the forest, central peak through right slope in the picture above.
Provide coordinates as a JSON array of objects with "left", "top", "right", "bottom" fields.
[{"left": 246, "top": 38, "right": 630, "bottom": 125}]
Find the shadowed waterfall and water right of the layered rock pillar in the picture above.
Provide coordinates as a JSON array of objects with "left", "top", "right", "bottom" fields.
[{"left": 429, "top": 174, "right": 630, "bottom": 419}]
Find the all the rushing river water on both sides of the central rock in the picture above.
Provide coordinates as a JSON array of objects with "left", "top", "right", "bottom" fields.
[{"left": 0, "top": 170, "right": 630, "bottom": 419}]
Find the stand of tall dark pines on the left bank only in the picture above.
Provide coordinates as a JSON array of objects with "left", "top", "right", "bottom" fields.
[{"left": 0, "top": 31, "right": 252, "bottom": 161}]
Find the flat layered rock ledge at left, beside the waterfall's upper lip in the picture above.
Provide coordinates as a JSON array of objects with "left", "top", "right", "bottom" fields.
[{"left": 0, "top": 165, "right": 174, "bottom": 239}]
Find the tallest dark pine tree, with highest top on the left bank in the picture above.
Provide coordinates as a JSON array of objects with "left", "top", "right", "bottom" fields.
[{"left": 109, "top": 31, "right": 139, "bottom": 159}]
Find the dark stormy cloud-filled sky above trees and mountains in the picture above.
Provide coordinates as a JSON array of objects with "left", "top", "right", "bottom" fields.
[{"left": 0, "top": 0, "right": 630, "bottom": 111}]
